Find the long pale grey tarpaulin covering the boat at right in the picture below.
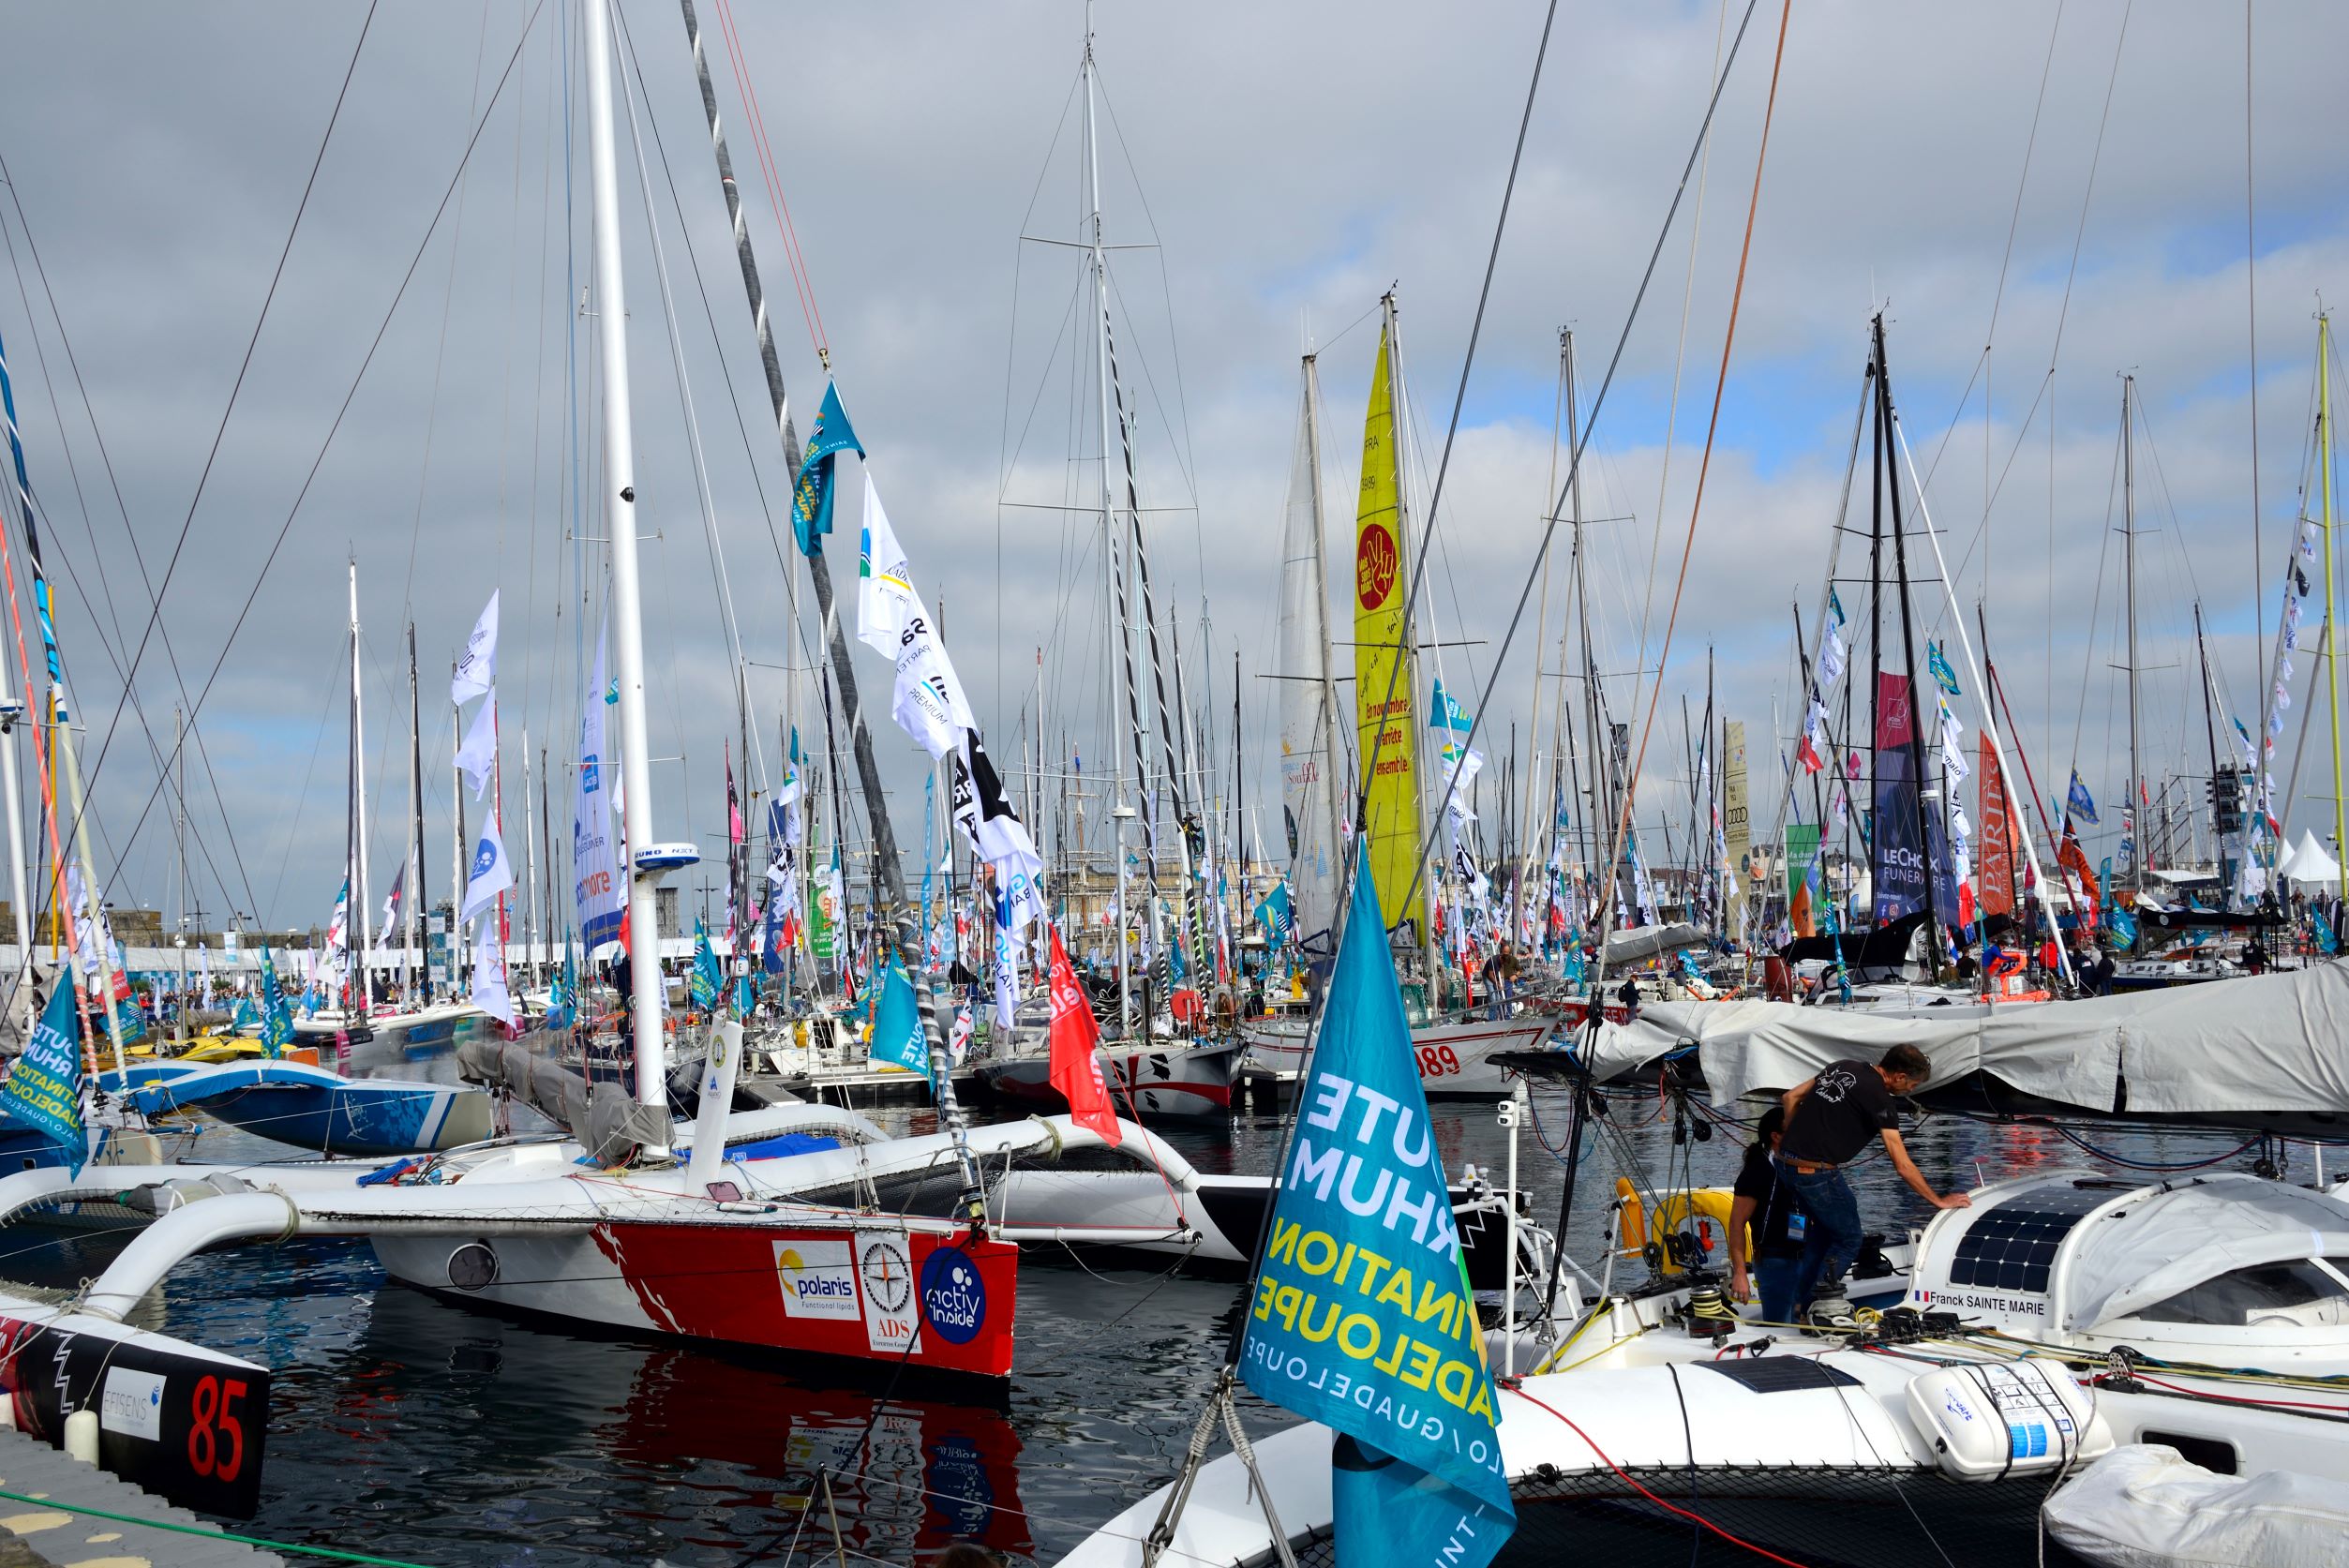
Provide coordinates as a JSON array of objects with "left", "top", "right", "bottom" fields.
[{"left": 1559, "top": 963, "right": 2349, "bottom": 1117}]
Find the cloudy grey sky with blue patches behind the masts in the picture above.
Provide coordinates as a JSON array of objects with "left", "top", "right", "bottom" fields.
[{"left": 0, "top": 0, "right": 2349, "bottom": 925}]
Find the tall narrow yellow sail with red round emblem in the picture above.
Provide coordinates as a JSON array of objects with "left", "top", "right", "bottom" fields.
[{"left": 1353, "top": 317, "right": 1419, "bottom": 930}]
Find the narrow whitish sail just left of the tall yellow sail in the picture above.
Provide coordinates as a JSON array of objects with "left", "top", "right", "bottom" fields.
[{"left": 1278, "top": 371, "right": 1343, "bottom": 946}]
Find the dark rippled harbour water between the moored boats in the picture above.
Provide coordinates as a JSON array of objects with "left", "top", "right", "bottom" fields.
[{"left": 0, "top": 1089, "right": 2273, "bottom": 1568}]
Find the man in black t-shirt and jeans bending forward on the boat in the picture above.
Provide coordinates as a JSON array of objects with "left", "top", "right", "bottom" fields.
[{"left": 1778, "top": 1044, "right": 1971, "bottom": 1329}]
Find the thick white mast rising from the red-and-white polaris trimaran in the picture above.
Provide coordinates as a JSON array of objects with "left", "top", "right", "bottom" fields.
[{"left": 585, "top": 0, "right": 669, "bottom": 1111}]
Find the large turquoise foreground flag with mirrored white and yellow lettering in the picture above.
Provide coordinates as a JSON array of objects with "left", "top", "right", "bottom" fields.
[{"left": 1240, "top": 875, "right": 1518, "bottom": 1568}]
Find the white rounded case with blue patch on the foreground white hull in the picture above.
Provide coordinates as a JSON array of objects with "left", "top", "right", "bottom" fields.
[{"left": 1908, "top": 1357, "right": 2112, "bottom": 1481}]
